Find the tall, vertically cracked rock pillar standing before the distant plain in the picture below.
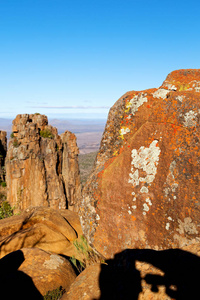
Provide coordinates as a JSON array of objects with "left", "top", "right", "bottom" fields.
[{"left": 6, "top": 114, "right": 80, "bottom": 210}]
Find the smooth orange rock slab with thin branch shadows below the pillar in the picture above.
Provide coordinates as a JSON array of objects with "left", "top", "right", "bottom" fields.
[{"left": 0, "top": 207, "right": 82, "bottom": 258}]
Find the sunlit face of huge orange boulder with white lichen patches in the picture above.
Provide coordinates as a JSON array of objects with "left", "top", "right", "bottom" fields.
[{"left": 79, "top": 70, "right": 200, "bottom": 258}]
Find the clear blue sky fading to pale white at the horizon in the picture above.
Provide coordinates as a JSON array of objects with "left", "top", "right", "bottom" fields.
[{"left": 0, "top": 0, "right": 200, "bottom": 118}]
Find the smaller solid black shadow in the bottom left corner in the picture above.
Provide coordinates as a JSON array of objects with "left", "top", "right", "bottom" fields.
[{"left": 0, "top": 250, "right": 43, "bottom": 300}]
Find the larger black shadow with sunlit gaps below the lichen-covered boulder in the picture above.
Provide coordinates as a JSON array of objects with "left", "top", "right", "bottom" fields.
[{"left": 99, "top": 249, "right": 200, "bottom": 300}]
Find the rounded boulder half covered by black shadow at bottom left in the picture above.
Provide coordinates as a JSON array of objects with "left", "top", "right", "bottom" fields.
[{"left": 0, "top": 248, "right": 76, "bottom": 300}]
